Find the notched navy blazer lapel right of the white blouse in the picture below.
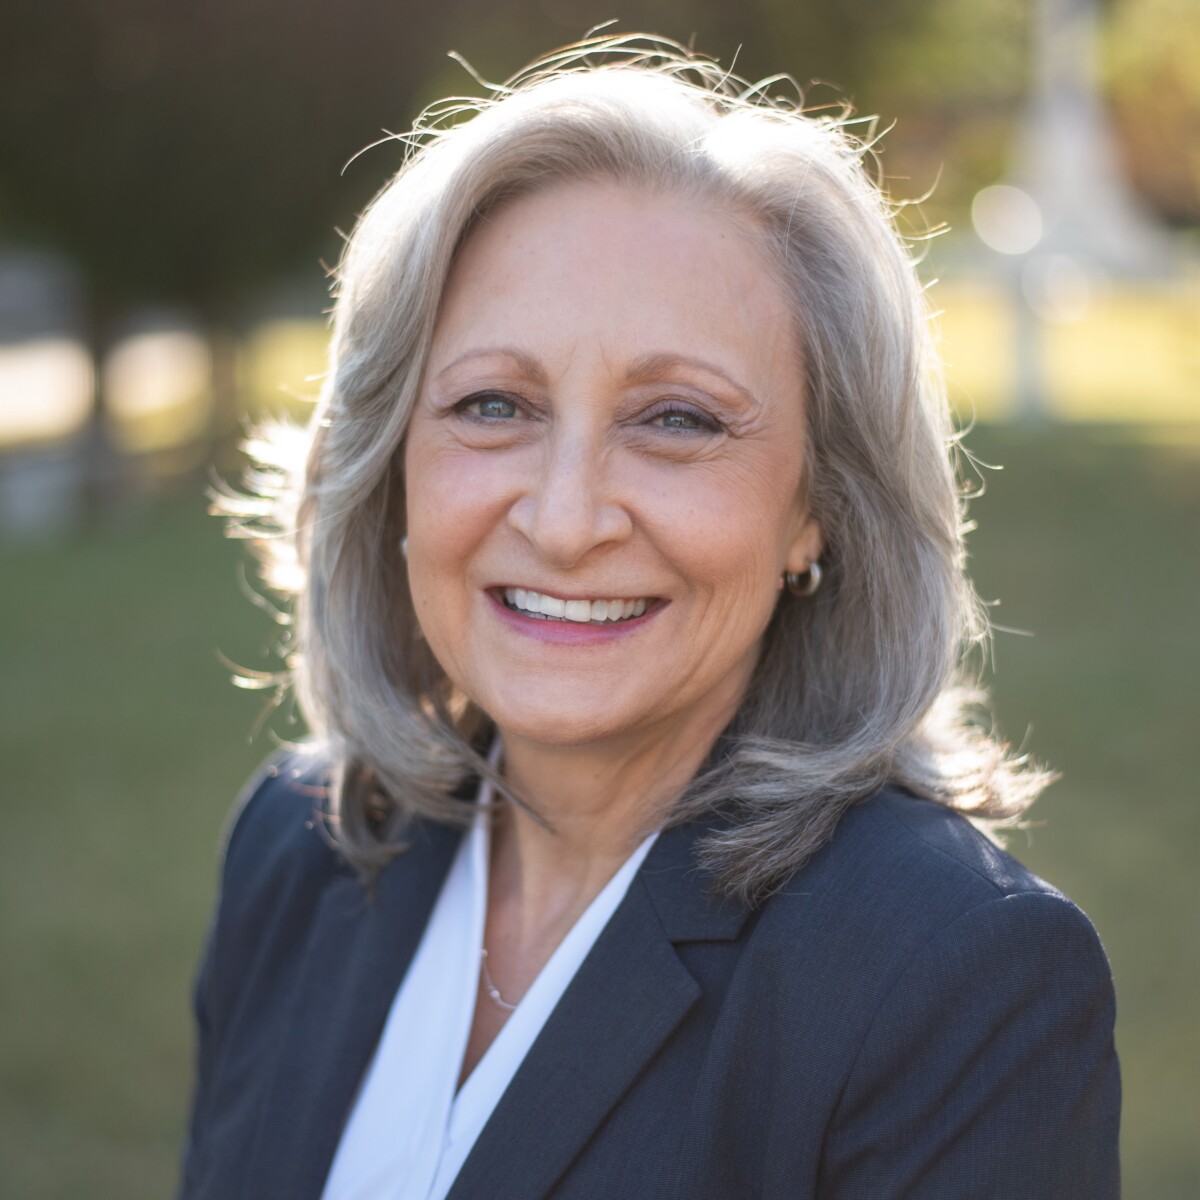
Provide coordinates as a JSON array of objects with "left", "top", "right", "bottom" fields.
[{"left": 448, "top": 826, "right": 746, "bottom": 1200}]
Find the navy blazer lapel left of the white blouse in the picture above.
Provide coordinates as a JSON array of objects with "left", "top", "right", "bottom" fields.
[{"left": 242, "top": 824, "right": 460, "bottom": 1200}]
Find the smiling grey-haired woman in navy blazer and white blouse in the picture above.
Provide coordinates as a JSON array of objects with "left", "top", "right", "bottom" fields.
[{"left": 184, "top": 32, "right": 1118, "bottom": 1200}]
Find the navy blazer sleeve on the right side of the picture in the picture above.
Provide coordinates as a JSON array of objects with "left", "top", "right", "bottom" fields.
[{"left": 817, "top": 892, "right": 1121, "bottom": 1200}]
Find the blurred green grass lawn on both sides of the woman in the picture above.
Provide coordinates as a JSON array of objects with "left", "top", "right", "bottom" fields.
[{"left": 0, "top": 426, "right": 1200, "bottom": 1200}]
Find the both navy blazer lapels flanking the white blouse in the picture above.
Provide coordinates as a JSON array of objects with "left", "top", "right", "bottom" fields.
[{"left": 244, "top": 823, "right": 748, "bottom": 1200}]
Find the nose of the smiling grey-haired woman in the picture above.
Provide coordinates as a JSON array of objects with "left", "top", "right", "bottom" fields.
[{"left": 509, "top": 432, "right": 634, "bottom": 569}]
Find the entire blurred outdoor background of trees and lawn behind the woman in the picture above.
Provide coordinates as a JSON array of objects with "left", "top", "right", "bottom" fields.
[{"left": 0, "top": 0, "right": 1200, "bottom": 1200}]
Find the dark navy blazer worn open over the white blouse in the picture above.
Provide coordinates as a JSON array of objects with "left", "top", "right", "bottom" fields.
[{"left": 181, "top": 758, "right": 1120, "bottom": 1200}]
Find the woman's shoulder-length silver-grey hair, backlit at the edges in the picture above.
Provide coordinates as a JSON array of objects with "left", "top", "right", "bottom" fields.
[{"left": 217, "top": 37, "right": 1045, "bottom": 900}]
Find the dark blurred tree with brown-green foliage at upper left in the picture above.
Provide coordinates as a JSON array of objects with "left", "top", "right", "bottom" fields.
[{"left": 0, "top": 0, "right": 451, "bottom": 499}]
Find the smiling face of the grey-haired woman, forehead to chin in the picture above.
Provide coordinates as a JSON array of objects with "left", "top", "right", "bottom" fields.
[{"left": 404, "top": 182, "right": 821, "bottom": 746}]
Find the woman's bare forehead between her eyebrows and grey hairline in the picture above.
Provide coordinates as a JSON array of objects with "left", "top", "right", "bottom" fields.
[{"left": 434, "top": 181, "right": 799, "bottom": 374}]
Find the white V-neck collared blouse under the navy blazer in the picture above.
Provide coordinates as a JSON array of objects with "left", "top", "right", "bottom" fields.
[{"left": 322, "top": 768, "right": 658, "bottom": 1200}]
